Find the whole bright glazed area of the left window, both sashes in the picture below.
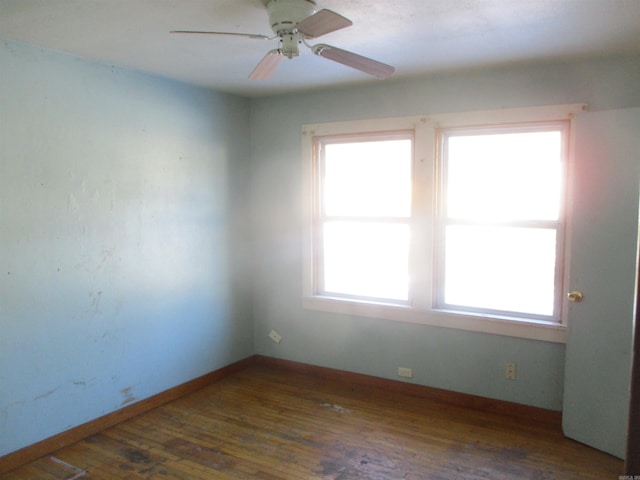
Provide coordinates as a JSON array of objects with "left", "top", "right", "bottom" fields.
[{"left": 317, "top": 135, "right": 413, "bottom": 302}]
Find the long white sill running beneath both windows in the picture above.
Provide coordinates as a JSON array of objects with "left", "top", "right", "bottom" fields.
[{"left": 302, "top": 296, "right": 567, "bottom": 343}]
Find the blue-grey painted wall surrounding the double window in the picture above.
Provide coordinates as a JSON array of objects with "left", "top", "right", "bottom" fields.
[{"left": 251, "top": 58, "right": 640, "bottom": 410}]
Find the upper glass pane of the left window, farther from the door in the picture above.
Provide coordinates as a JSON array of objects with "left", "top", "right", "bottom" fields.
[{"left": 323, "top": 139, "right": 412, "bottom": 217}]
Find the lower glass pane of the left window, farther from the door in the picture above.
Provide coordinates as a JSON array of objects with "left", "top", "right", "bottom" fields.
[{"left": 324, "top": 222, "right": 409, "bottom": 300}]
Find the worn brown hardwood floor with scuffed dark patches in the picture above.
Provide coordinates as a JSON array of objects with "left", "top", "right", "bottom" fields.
[{"left": 3, "top": 365, "right": 623, "bottom": 480}]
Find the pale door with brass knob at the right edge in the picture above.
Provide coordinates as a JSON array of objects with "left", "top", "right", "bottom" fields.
[{"left": 562, "top": 108, "right": 640, "bottom": 458}]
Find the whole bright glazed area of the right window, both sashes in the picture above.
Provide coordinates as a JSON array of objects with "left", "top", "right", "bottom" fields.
[{"left": 440, "top": 126, "right": 564, "bottom": 317}]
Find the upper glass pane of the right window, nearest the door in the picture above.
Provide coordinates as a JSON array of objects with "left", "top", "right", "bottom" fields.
[{"left": 446, "top": 131, "right": 562, "bottom": 220}]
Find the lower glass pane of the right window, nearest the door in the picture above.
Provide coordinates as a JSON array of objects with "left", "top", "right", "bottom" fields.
[{"left": 444, "top": 225, "right": 556, "bottom": 316}]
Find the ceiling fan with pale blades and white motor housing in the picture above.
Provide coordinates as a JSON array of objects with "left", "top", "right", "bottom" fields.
[{"left": 171, "top": 0, "right": 395, "bottom": 80}]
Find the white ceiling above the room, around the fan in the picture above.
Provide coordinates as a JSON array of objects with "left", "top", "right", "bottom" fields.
[{"left": 0, "top": 0, "right": 640, "bottom": 96}]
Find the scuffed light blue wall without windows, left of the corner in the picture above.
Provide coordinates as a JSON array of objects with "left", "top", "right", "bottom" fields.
[{"left": 0, "top": 42, "right": 253, "bottom": 456}]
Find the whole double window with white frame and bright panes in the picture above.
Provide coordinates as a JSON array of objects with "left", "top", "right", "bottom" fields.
[{"left": 303, "top": 105, "right": 584, "bottom": 342}]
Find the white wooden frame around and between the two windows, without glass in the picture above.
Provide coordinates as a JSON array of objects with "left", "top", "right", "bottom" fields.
[{"left": 302, "top": 104, "right": 586, "bottom": 343}]
